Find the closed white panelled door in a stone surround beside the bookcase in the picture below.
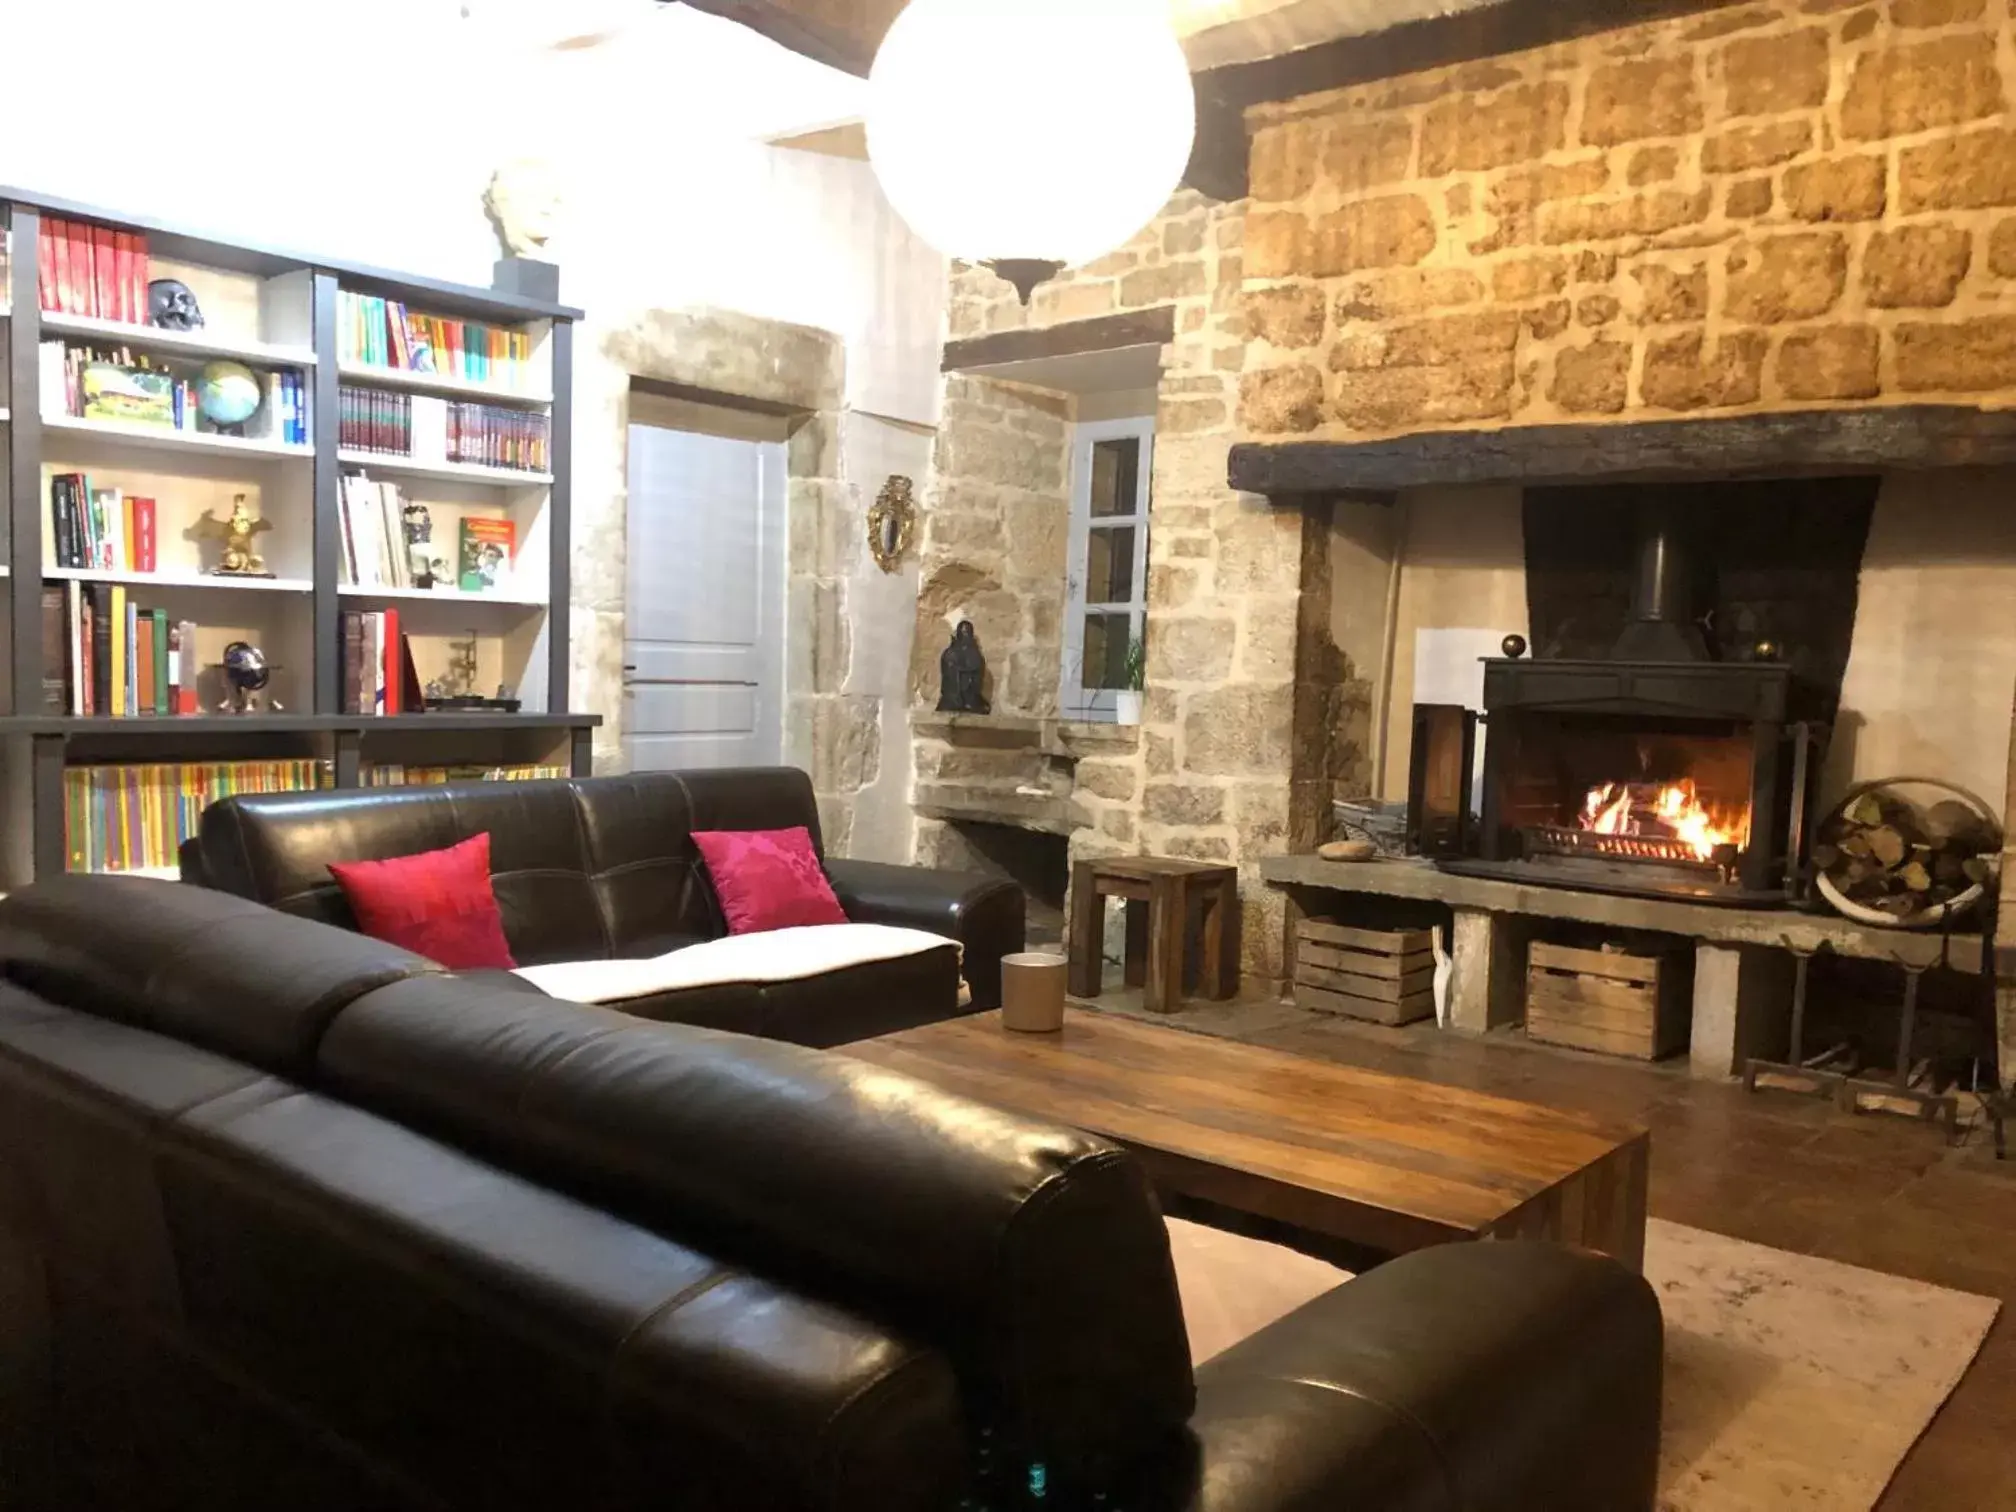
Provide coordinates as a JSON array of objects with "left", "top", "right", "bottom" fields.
[{"left": 623, "top": 425, "right": 786, "bottom": 772}]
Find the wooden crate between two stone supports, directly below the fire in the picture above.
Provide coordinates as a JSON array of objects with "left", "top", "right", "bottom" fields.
[{"left": 1526, "top": 939, "right": 1693, "bottom": 1060}]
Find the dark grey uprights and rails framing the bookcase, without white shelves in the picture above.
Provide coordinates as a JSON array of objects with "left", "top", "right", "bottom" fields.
[{"left": 0, "top": 187, "right": 601, "bottom": 875}]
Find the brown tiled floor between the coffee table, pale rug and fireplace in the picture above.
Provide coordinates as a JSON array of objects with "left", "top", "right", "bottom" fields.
[{"left": 1101, "top": 994, "right": 2016, "bottom": 1512}]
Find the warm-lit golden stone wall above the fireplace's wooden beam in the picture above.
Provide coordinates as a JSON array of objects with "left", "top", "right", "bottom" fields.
[{"left": 1240, "top": 0, "right": 2016, "bottom": 439}]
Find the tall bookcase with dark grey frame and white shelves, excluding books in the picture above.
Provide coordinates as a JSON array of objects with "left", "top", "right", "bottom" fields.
[{"left": 0, "top": 187, "right": 601, "bottom": 887}]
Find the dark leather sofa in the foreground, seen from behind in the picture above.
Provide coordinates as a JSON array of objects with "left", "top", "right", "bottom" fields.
[{"left": 0, "top": 877, "right": 1661, "bottom": 1512}]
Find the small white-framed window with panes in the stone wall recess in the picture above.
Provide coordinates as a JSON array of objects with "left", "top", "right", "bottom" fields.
[{"left": 1058, "top": 415, "right": 1155, "bottom": 722}]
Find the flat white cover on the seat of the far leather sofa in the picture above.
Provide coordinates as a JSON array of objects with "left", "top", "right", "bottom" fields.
[{"left": 518, "top": 923, "right": 958, "bottom": 1002}]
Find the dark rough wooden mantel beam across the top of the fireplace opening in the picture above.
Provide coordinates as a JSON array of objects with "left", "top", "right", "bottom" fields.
[{"left": 1230, "top": 405, "right": 2016, "bottom": 500}]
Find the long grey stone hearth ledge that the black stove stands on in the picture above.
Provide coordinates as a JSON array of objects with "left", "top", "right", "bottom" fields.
[{"left": 1260, "top": 855, "right": 1982, "bottom": 972}]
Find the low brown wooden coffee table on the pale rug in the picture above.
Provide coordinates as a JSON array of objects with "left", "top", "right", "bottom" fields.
[{"left": 843, "top": 1010, "right": 1651, "bottom": 1270}]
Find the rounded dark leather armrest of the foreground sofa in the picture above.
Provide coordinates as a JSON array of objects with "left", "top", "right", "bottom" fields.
[{"left": 1143, "top": 1242, "right": 1663, "bottom": 1512}]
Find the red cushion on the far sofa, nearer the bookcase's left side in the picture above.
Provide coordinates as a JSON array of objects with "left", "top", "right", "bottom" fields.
[{"left": 329, "top": 835, "right": 518, "bottom": 972}]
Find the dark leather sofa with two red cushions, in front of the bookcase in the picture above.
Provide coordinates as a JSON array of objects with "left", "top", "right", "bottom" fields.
[{"left": 181, "top": 768, "right": 1024, "bottom": 1046}]
